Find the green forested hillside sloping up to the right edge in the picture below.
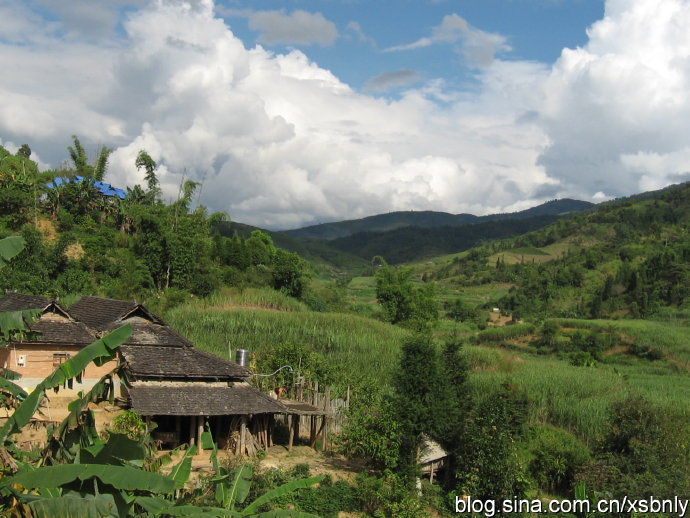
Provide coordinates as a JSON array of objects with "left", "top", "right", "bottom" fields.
[{"left": 434, "top": 184, "right": 690, "bottom": 318}]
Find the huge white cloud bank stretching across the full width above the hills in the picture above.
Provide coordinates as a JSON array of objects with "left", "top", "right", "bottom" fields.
[{"left": 0, "top": 0, "right": 690, "bottom": 228}]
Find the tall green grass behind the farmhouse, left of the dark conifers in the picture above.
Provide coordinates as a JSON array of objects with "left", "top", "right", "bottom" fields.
[{"left": 166, "top": 306, "right": 409, "bottom": 384}]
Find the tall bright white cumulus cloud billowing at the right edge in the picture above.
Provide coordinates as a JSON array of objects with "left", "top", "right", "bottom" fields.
[{"left": 540, "top": 0, "right": 690, "bottom": 196}]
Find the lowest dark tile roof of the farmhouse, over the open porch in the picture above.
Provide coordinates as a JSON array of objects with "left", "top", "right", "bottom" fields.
[{"left": 129, "top": 382, "right": 287, "bottom": 416}]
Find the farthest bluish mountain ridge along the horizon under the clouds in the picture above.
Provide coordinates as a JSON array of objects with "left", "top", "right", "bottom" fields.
[{"left": 281, "top": 198, "right": 594, "bottom": 241}]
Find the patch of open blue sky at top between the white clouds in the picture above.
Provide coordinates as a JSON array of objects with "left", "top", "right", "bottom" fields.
[{"left": 218, "top": 0, "right": 604, "bottom": 93}]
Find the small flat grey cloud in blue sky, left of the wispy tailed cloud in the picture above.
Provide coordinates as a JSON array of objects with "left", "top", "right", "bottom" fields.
[{"left": 249, "top": 10, "right": 338, "bottom": 47}]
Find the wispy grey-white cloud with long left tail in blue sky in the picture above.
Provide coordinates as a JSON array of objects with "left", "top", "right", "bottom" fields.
[{"left": 386, "top": 14, "right": 510, "bottom": 67}]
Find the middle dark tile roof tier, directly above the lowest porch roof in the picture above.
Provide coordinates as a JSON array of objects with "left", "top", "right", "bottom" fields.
[{"left": 120, "top": 345, "right": 250, "bottom": 380}]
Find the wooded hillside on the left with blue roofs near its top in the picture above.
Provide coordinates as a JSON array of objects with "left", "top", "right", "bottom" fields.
[{"left": 0, "top": 137, "right": 307, "bottom": 305}]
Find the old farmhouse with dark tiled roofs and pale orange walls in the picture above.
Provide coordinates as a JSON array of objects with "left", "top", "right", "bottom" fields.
[{"left": 0, "top": 293, "right": 288, "bottom": 455}]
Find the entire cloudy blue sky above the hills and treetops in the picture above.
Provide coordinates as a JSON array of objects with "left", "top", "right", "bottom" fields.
[{"left": 0, "top": 0, "right": 690, "bottom": 229}]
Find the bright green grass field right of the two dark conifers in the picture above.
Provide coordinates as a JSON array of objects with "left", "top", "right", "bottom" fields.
[{"left": 465, "top": 319, "right": 690, "bottom": 446}]
